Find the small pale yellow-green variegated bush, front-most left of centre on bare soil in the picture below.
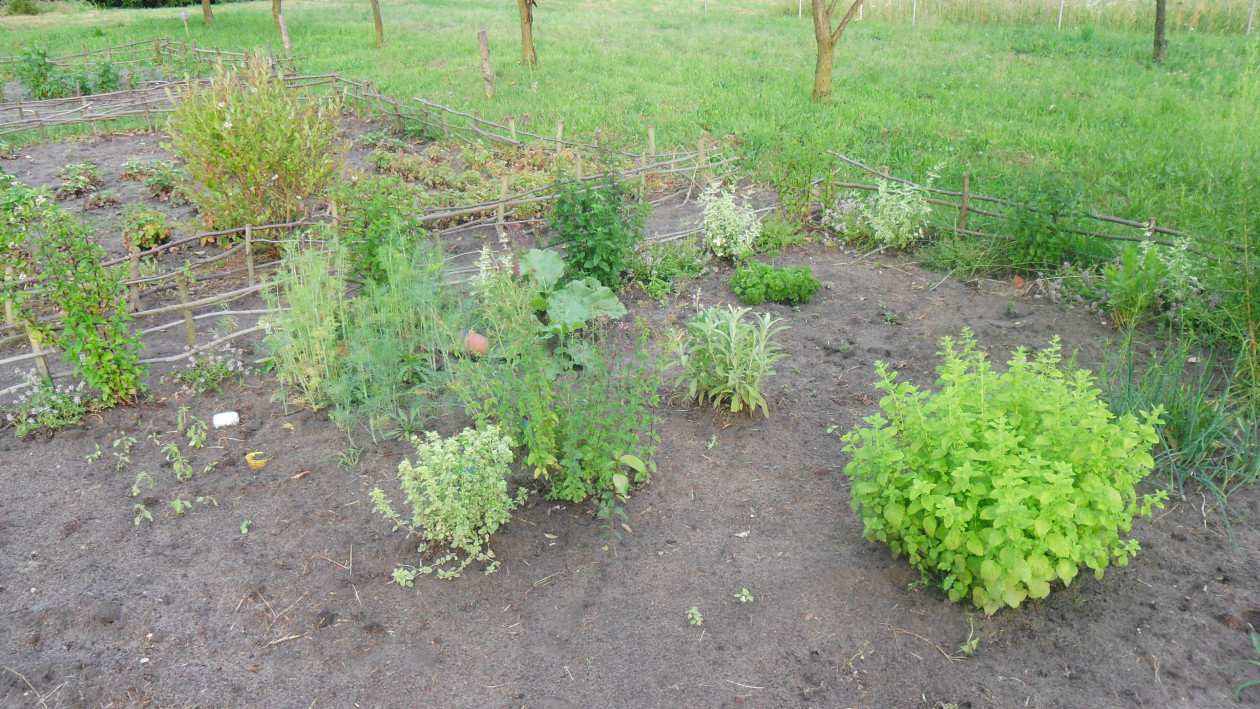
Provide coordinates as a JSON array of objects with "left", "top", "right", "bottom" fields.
[{"left": 370, "top": 427, "right": 528, "bottom": 578}]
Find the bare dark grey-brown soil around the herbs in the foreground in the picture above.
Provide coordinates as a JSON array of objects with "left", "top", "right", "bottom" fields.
[{"left": 0, "top": 240, "right": 1260, "bottom": 708}]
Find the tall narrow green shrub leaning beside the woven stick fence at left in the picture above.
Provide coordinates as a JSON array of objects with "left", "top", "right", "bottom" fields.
[{"left": 38, "top": 210, "right": 146, "bottom": 406}]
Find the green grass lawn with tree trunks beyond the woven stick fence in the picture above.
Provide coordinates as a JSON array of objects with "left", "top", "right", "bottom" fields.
[{"left": 7, "top": 0, "right": 1260, "bottom": 234}]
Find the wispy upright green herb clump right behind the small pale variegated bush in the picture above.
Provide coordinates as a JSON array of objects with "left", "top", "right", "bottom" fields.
[{"left": 451, "top": 251, "right": 660, "bottom": 502}]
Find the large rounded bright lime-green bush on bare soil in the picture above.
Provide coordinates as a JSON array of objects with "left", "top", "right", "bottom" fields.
[{"left": 843, "top": 330, "right": 1167, "bottom": 615}]
